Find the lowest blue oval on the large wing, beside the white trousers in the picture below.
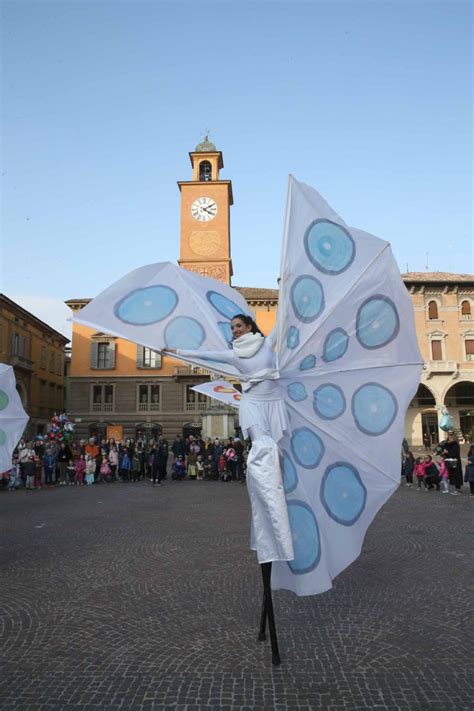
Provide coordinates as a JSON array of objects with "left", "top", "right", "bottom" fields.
[{"left": 288, "top": 501, "right": 321, "bottom": 575}]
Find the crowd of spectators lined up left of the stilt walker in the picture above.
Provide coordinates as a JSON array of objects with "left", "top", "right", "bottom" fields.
[{"left": 0, "top": 435, "right": 247, "bottom": 491}]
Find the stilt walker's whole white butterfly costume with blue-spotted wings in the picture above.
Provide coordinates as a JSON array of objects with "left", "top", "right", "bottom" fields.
[{"left": 75, "top": 177, "right": 422, "bottom": 595}]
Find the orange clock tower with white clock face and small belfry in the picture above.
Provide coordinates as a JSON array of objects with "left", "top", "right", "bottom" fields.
[{"left": 178, "top": 136, "right": 233, "bottom": 284}]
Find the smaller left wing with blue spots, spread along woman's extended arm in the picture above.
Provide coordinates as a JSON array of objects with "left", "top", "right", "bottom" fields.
[{"left": 74, "top": 262, "right": 251, "bottom": 376}]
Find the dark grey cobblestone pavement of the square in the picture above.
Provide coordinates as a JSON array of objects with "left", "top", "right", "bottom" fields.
[{"left": 0, "top": 482, "right": 474, "bottom": 711}]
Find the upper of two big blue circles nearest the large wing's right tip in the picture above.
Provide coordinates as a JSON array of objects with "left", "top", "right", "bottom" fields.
[{"left": 356, "top": 294, "right": 400, "bottom": 349}]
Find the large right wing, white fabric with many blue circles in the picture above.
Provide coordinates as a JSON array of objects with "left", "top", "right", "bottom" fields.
[{"left": 272, "top": 178, "right": 422, "bottom": 595}]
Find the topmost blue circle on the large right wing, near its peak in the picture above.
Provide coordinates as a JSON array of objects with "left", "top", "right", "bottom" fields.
[{"left": 304, "top": 220, "right": 355, "bottom": 274}]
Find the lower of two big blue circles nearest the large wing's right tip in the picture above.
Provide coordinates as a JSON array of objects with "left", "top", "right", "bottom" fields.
[{"left": 352, "top": 383, "right": 398, "bottom": 436}]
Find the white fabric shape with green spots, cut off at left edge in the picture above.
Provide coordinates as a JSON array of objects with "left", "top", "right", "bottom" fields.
[{"left": 0, "top": 363, "right": 29, "bottom": 472}]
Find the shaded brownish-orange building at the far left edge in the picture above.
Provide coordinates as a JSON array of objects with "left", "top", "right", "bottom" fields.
[{"left": 0, "top": 294, "right": 69, "bottom": 437}]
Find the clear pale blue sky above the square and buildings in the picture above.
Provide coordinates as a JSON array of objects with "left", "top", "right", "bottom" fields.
[{"left": 1, "top": 0, "right": 474, "bottom": 334}]
